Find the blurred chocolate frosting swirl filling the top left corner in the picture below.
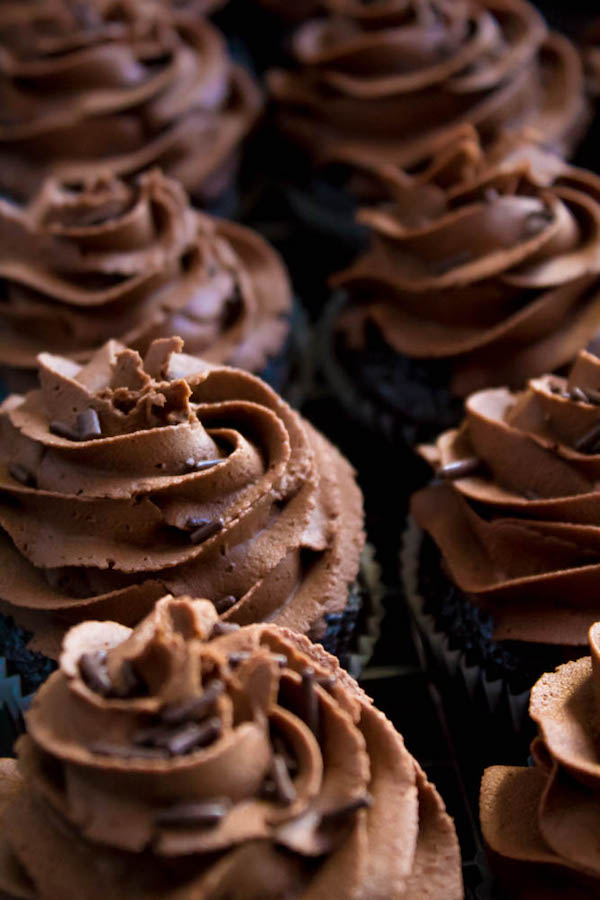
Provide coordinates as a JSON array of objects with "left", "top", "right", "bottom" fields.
[{"left": 0, "top": 0, "right": 261, "bottom": 201}]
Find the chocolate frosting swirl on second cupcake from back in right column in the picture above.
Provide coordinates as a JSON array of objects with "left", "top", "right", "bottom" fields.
[{"left": 334, "top": 140, "right": 600, "bottom": 396}]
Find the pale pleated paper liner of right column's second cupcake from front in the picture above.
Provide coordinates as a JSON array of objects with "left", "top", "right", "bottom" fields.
[{"left": 400, "top": 518, "right": 530, "bottom": 746}]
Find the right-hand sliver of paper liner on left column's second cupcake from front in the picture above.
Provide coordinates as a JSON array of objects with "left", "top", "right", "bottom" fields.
[{"left": 319, "top": 544, "right": 384, "bottom": 678}]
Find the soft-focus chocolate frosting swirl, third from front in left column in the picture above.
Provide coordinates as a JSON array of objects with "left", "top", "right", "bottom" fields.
[{"left": 0, "top": 170, "right": 291, "bottom": 371}]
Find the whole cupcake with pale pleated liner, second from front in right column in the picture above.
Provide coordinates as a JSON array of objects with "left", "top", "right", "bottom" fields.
[{"left": 404, "top": 351, "right": 600, "bottom": 693}]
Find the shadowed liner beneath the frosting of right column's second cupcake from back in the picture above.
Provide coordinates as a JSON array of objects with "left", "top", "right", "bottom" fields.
[{"left": 318, "top": 291, "right": 463, "bottom": 447}]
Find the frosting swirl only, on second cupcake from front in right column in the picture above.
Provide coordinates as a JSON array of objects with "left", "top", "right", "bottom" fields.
[{"left": 412, "top": 351, "right": 600, "bottom": 652}]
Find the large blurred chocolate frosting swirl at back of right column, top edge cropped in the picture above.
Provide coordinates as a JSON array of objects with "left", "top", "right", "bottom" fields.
[{"left": 270, "top": 0, "right": 586, "bottom": 176}]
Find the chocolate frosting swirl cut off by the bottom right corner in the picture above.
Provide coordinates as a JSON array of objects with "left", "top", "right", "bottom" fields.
[{"left": 480, "top": 623, "right": 600, "bottom": 900}]
